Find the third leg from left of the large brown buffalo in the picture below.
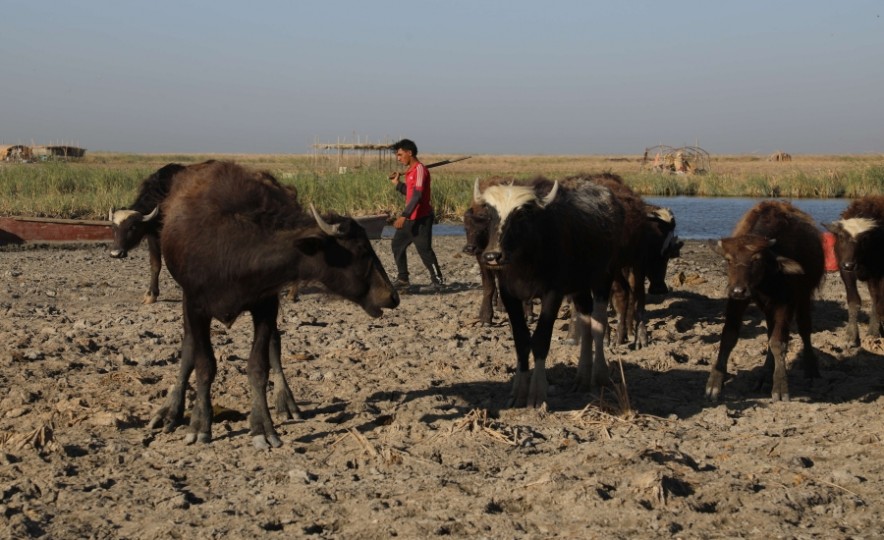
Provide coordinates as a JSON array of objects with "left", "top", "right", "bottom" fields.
[{"left": 246, "top": 296, "right": 282, "bottom": 450}]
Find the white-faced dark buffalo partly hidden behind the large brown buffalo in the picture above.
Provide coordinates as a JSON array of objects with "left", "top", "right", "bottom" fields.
[{"left": 108, "top": 163, "right": 185, "bottom": 304}]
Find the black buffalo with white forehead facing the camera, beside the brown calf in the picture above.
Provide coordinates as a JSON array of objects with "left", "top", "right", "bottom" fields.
[{"left": 474, "top": 175, "right": 624, "bottom": 407}]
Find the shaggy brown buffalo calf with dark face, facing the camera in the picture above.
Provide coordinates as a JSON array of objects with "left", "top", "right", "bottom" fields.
[{"left": 706, "top": 201, "right": 824, "bottom": 400}]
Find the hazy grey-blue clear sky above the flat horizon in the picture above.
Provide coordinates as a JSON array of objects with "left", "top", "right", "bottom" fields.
[{"left": 0, "top": 0, "right": 884, "bottom": 155}]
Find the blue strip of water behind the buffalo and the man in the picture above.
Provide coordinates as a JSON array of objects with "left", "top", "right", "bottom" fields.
[{"left": 383, "top": 197, "right": 851, "bottom": 240}]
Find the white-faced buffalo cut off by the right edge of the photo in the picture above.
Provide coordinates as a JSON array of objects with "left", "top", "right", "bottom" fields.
[{"left": 826, "top": 195, "right": 884, "bottom": 347}]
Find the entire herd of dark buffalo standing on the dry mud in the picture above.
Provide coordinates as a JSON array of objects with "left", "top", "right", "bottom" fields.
[{"left": 103, "top": 160, "right": 884, "bottom": 448}]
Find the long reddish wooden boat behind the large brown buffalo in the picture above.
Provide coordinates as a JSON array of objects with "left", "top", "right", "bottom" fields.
[{"left": 0, "top": 214, "right": 389, "bottom": 246}]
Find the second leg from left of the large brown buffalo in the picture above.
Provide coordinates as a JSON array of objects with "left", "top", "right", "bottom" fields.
[{"left": 184, "top": 305, "right": 218, "bottom": 444}]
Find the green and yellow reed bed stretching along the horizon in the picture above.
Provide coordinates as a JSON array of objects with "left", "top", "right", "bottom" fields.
[{"left": 0, "top": 152, "right": 884, "bottom": 220}]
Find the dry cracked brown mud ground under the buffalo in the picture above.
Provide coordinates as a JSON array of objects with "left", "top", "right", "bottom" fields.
[{"left": 0, "top": 237, "right": 884, "bottom": 538}]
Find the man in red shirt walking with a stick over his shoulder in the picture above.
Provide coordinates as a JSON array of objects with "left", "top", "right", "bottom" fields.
[{"left": 390, "top": 139, "right": 445, "bottom": 292}]
